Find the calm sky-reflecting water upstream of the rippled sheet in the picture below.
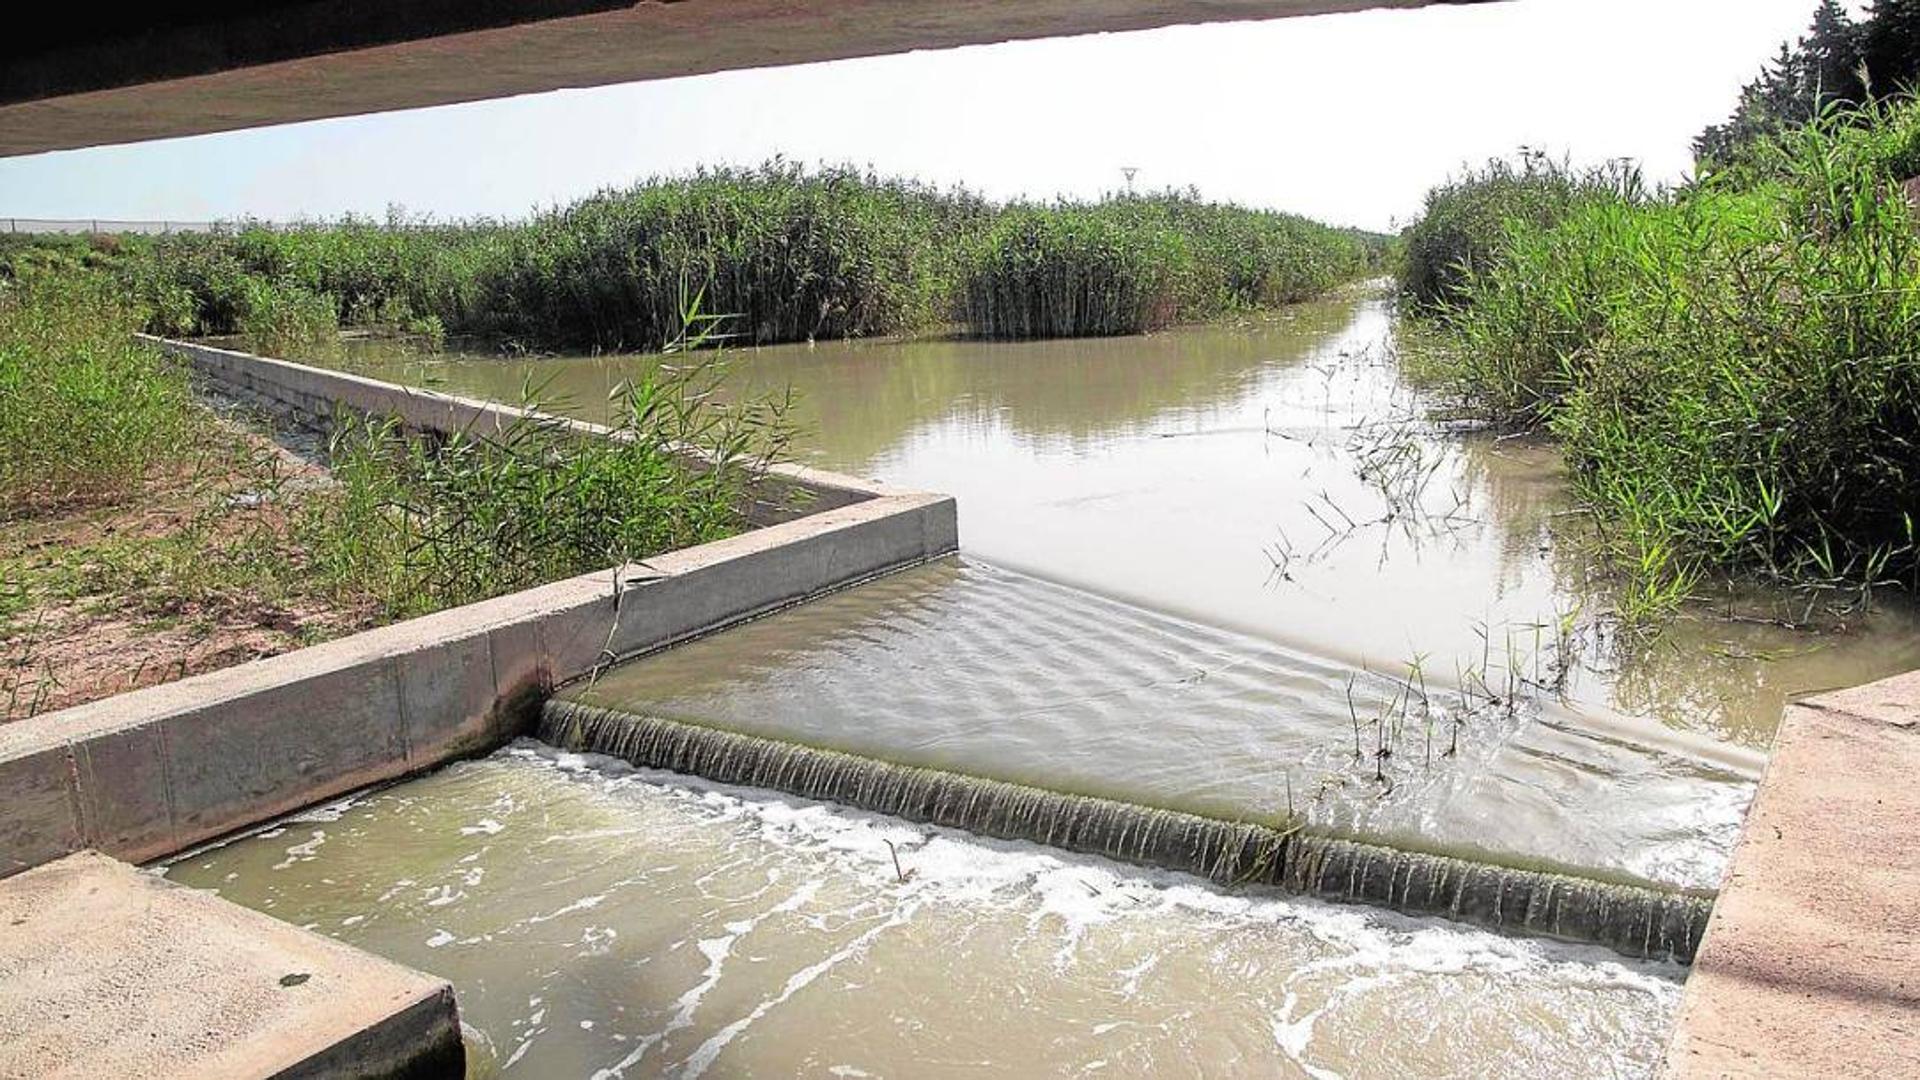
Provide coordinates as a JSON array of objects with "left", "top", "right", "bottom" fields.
[{"left": 307, "top": 298, "right": 1920, "bottom": 748}]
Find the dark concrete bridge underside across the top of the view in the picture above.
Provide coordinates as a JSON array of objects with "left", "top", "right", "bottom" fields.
[{"left": 0, "top": 0, "right": 1478, "bottom": 156}]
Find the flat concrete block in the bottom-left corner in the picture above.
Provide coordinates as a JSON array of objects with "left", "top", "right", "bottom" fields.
[{"left": 0, "top": 851, "right": 465, "bottom": 1080}]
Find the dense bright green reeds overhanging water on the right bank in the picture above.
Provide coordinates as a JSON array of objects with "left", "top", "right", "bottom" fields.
[{"left": 1405, "top": 100, "right": 1920, "bottom": 611}]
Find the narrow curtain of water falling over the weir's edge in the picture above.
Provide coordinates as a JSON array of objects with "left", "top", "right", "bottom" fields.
[{"left": 540, "top": 700, "right": 1711, "bottom": 963}]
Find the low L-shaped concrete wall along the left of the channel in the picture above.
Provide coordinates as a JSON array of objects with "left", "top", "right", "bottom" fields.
[{"left": 0, "top": 346, "right": 958, "bottom": 876}]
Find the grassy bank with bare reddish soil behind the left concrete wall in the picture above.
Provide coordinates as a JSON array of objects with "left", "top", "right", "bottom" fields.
[{"left": 0, "top": 265, "right": 789, "bottom": 721}]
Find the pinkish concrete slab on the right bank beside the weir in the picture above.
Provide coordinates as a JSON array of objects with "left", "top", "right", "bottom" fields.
[{"left": 1663, "top": 673, "right": 1920, "bottom": 1080}]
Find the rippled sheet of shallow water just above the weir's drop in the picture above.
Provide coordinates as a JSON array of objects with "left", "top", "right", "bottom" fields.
[{"left": 564, "top": 555, "right": 1759, "bottom": 890}]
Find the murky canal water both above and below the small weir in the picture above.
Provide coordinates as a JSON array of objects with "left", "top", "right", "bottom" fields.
[{"left": 169, "top": 294, "right": 1920, "bottom": 1076}]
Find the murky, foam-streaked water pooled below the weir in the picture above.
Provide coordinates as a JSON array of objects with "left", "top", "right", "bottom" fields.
[{"left": 169, "top": 744, "right": 1678, "bottom": 1078}]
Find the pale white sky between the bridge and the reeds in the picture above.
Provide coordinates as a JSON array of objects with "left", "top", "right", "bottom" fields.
[{"left": 0, "top": 0, "right": 1858, "bottom": 229}]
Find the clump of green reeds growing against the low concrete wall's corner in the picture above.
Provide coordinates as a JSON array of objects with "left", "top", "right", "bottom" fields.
[{"left": 296, "top": 353, "right": 791, "bottom": 619}]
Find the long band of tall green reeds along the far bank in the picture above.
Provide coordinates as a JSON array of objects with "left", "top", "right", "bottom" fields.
[{"left": 0, "top": 161, "right": 1386, "bottom": 350}]
